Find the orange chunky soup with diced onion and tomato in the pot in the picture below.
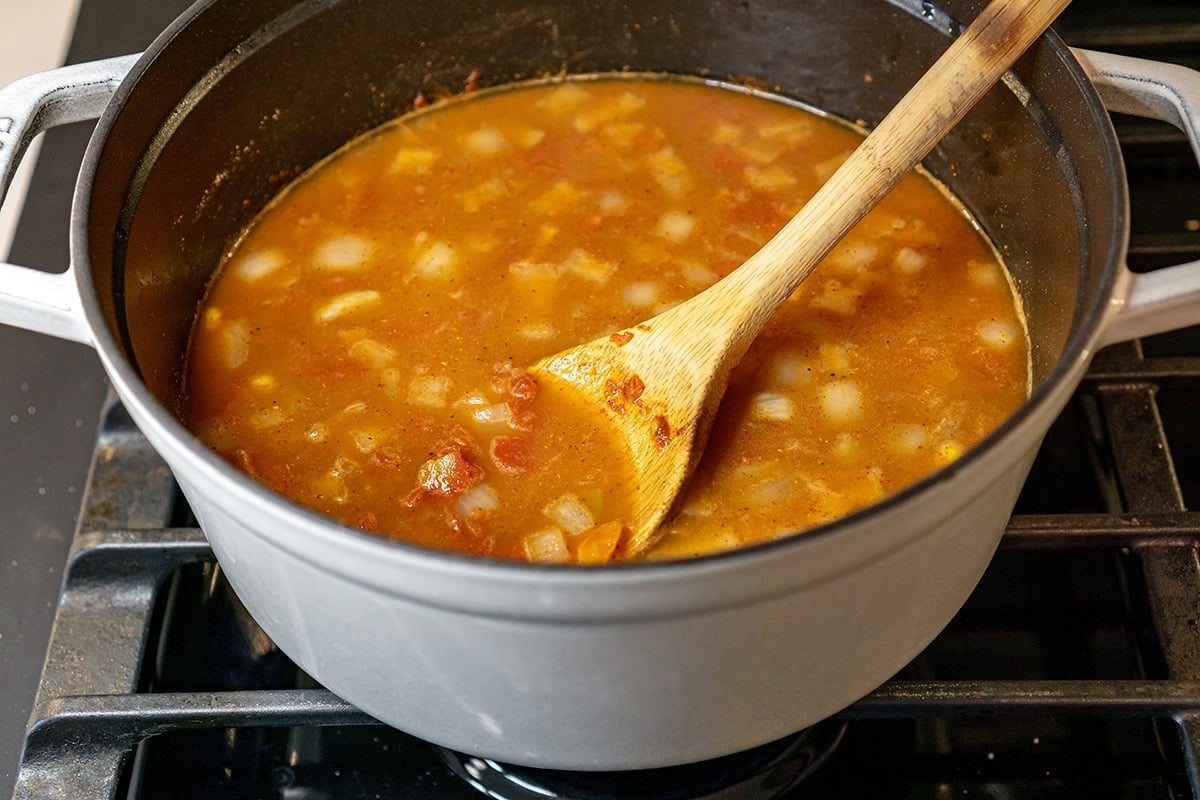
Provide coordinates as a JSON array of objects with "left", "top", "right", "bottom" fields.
[{"left": 185, "top": 76, "right": 1030, "bottom": 564}]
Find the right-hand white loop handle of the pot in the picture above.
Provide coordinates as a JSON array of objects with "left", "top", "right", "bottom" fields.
[{"left": 1074, "top": 49, "right": 1200, "bottom": 347}]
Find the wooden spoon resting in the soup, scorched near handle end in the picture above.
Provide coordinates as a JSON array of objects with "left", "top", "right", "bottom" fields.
[{"left": 530, "top": 0, "right": 1070, "bottom": 555}]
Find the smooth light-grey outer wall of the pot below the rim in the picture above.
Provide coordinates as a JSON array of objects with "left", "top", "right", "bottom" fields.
[{"left": 119, "top": 357, "right": 1060, "bottom": 770}]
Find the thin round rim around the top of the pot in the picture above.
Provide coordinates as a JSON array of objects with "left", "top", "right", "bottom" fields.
[{"left": 70, "top": 0, "right": 1129, "bottom": 594}]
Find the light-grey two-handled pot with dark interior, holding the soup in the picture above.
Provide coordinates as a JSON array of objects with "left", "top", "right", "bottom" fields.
[{"left": 0, "top": 0, "right": 1200, "bottom": 770}]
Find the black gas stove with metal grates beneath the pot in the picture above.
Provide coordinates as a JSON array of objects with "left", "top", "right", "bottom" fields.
[{"left": 7, "top": 0, "right": 1200, "bottom": 800}]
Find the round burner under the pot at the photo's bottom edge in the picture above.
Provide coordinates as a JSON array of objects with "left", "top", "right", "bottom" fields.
[{"left": 438, "top": 720, "right": 848, "bottom": 800}]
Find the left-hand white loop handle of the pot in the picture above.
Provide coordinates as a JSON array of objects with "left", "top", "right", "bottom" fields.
[{"left": 0, "top": 55, "right": 138, "bottom": 344}]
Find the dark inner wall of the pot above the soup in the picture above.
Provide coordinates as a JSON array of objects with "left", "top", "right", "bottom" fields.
[{"left": 86, "top": 0, "right": 1124, "bottom": 419}]
